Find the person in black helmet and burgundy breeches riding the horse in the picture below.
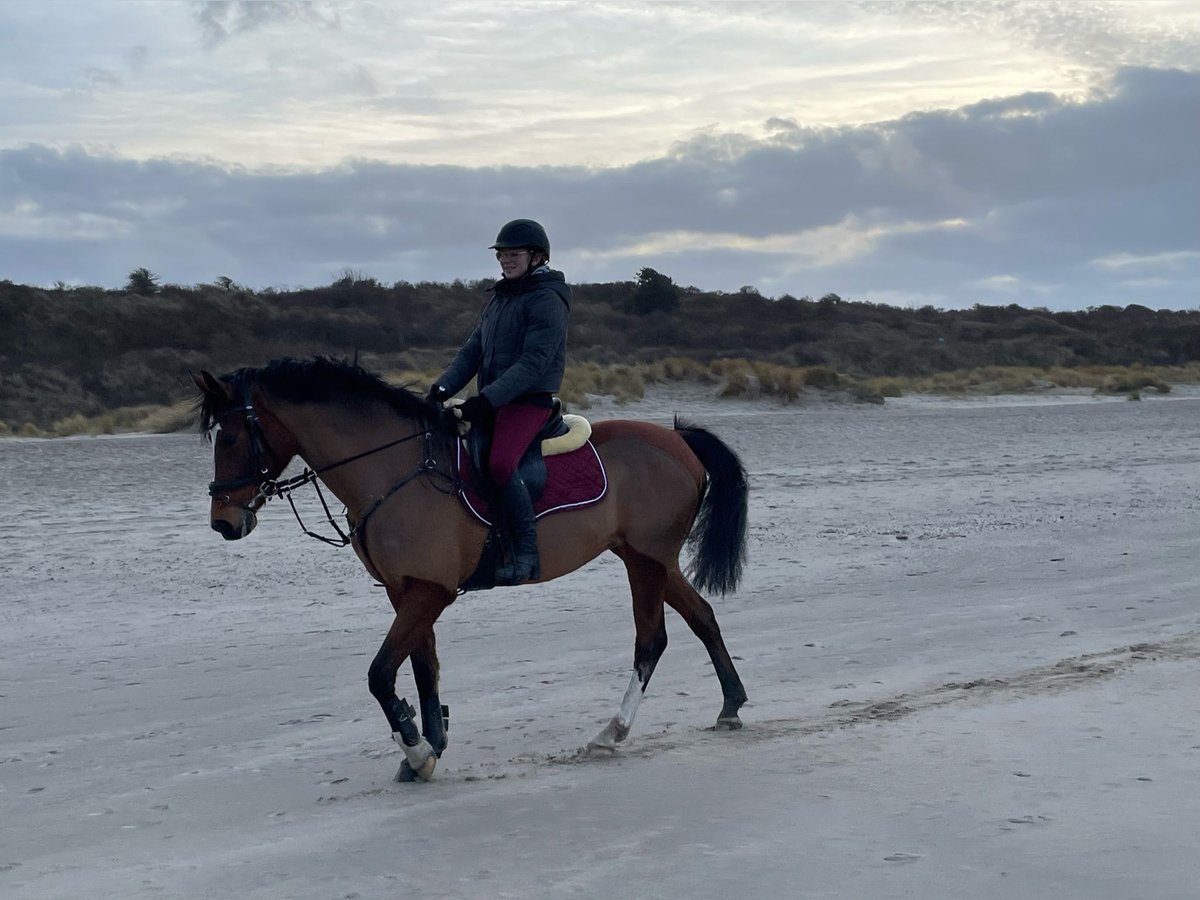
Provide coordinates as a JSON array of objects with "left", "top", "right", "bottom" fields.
[{"left": 428, "top": 218, "right": 571, "bottom": 584}]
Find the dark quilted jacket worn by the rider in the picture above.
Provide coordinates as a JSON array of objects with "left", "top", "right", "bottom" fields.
[{"left": 438, "top": 269, "right": 571, "bottom": 407}]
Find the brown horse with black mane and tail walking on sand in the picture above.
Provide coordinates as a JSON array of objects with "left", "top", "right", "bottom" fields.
[{"left": 193, "top": 358, "right": 746, "bottom": 780}]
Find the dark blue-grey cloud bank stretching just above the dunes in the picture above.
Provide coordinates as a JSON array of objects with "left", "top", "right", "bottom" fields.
[{"left": 0, "top": 70, "right": 1200, "bottom": 308}]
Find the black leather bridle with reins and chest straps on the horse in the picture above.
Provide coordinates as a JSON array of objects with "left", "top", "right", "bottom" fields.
[{"left": 209, "top": 383, "right": 462, "bottom": 553}]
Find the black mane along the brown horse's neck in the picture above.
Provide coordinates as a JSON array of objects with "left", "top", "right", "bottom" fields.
[{"left": 197, "top": 356, "right": 442, "bottom": 432}]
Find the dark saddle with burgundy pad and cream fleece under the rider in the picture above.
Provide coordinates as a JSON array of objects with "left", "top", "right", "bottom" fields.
[{"left": 455, "top": 400, "right": 608, "bottom": 592}]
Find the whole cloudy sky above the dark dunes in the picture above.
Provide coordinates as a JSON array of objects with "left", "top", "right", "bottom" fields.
[{"left": 0, "top": 0, "right": 1200, "bottom": 310}]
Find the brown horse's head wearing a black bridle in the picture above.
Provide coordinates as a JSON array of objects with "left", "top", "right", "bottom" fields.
[{"left": 192, "top": 370, "right": 295, "bottom": 541}]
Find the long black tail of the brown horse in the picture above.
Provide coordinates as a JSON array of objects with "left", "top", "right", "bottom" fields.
[{"left": 674, "top": 416, "right": 746, "bottom": 594}]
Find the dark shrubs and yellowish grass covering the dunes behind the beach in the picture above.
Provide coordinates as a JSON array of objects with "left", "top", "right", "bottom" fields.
[{"left": 0, "top": 269, "right": 1200, "bottom": 436}]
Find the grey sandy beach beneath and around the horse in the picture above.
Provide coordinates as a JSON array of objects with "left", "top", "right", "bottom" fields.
[{"left": 0, "top": 388, "right": 1200, "bottom": 900}]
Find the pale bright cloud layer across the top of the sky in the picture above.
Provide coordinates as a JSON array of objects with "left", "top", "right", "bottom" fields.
[{"left": 7, "top": 0, "right": 1200, "bottom": 168}]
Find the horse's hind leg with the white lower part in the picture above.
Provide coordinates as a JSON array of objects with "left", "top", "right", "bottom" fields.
[{"left": 588, "top": 547, "right": 667, "bottom": 751}]
